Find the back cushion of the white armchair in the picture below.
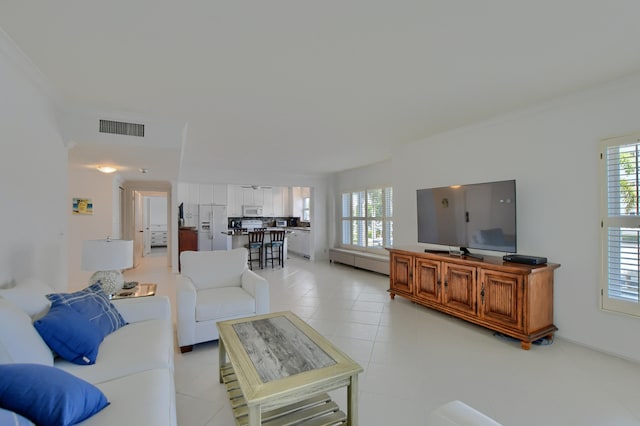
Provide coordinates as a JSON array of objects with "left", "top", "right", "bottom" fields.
[{"left": 180, "top": 248, "right": 247, "bottom": 289}]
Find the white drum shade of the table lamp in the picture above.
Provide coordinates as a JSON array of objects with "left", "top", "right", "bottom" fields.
[{"left": 82, "top": 240, "right": 133, "bottom": 271}]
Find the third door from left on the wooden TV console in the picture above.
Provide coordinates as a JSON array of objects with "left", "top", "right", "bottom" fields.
[{"left": 442, "top": 262, "right": 477, "bottom": 315}]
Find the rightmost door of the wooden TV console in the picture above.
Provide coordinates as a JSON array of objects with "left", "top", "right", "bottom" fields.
[{"left": 478, "top": 269, "right": 524, "bottom": 330}]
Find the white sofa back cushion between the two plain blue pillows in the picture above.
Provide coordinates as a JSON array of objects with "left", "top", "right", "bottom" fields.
[{"left": 0, "top": 297, "right": 53, "bottom": 366}]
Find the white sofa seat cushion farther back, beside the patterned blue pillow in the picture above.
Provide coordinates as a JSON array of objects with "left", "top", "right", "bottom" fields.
[{"left": 55, "top": 320, "right": 174, "bottom": 384}]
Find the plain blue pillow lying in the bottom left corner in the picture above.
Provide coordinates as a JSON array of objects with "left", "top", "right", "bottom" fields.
[{"left": 0, "top": 364, "right": 109, "bottom": 426}]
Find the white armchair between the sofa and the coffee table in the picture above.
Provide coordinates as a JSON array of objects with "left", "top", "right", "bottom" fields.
[{"left": 176, "top": 248, "right": 269, "bottom": 353}]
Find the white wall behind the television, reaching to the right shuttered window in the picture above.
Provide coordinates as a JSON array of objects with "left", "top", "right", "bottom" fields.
[{"left": 392, "top": 75, "right": 640, "bottom": 361}]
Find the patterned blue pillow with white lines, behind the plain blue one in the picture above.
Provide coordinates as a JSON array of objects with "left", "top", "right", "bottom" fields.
[{"left": 47, "top": 283, "right": 127, "bottom": 337}]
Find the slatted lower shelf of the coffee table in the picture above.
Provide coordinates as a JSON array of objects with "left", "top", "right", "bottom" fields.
[{"left": 220, "top": 363, "right": 347, "bottom": 426}]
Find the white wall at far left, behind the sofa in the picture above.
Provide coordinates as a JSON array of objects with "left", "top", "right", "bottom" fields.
[{"left": 0, "top": 31, "right": 71, "bottom": 290}]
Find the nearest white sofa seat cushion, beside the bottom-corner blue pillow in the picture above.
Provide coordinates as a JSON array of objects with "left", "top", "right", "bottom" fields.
[{"left": 78, "top": 369, "right": 176, "bottom": 426}]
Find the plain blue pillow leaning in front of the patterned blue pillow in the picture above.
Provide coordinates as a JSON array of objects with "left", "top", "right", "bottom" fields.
[{"left": 33, "top": 302, "right": 103, "bottom": 365}]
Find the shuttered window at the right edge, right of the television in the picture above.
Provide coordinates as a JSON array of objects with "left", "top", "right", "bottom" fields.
[{"left": 600, "top": 134, "right": 640, "bottom": 316}]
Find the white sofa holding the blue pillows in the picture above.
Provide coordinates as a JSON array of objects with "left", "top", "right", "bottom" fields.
[{"left": 0, "top": 282, "right": 176, "bottom": 426}]
